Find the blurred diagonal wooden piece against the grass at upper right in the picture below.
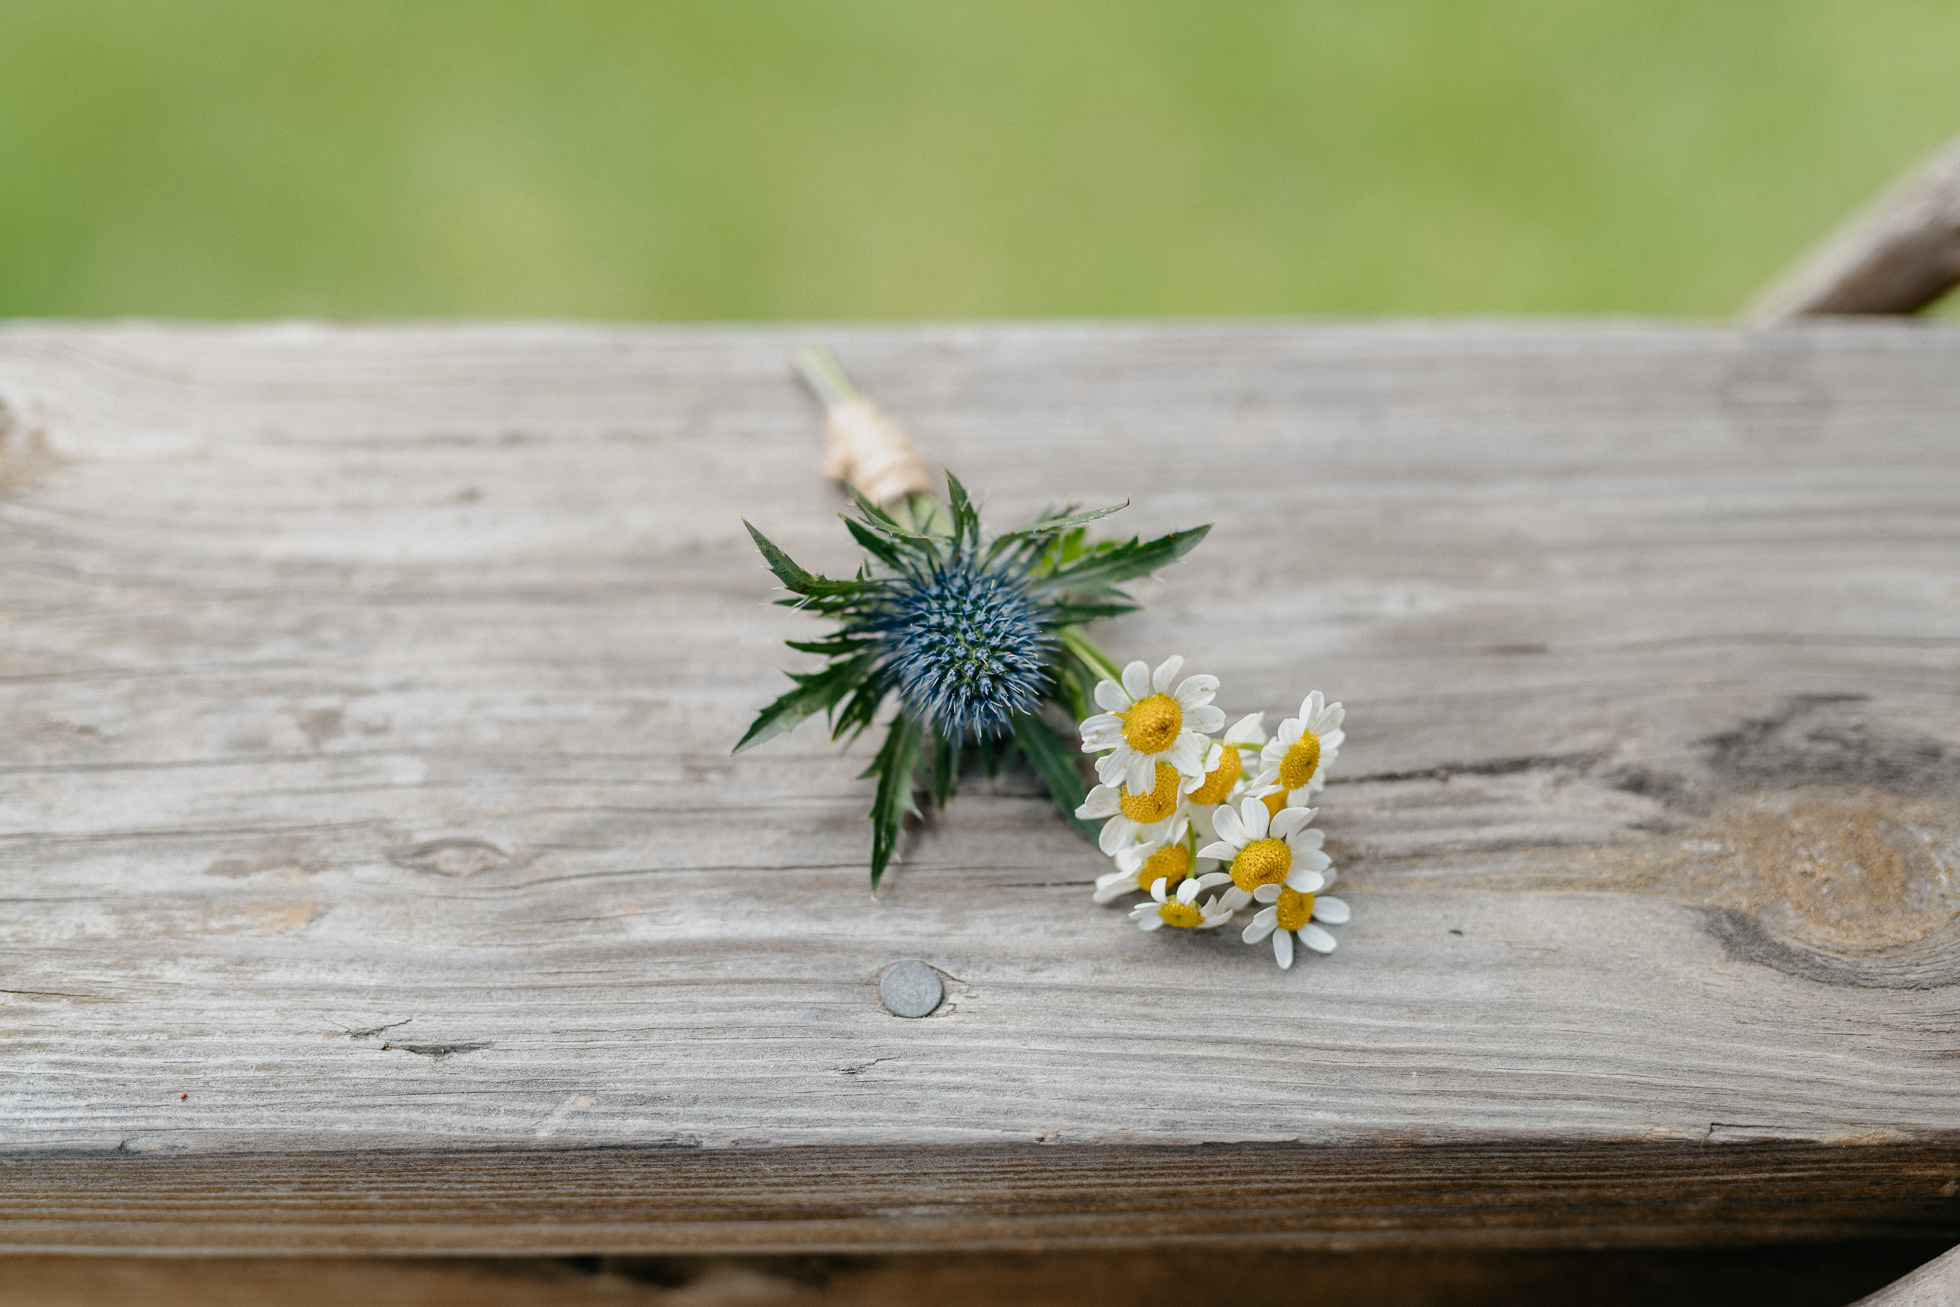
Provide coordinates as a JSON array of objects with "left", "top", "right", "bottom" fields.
[{"left": 1750, "top": 137, "right": 1960, "bottom": 321}]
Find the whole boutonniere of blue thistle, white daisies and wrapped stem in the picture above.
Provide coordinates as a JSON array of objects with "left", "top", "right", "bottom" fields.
[{"left": 735, "top": 351, "right": 1348, "bottom": 966}]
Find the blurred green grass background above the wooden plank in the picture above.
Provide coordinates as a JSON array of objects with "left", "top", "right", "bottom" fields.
[{"left": 0, "top": 0, "right": 1960, "bottom": 319}]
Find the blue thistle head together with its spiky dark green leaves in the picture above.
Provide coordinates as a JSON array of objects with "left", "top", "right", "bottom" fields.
[{"left": 735, "top": 472, "right": 1211, "bottom": 890}]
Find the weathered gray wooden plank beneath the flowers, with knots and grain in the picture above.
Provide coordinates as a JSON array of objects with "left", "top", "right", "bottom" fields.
[{"left": 0, "top": 323, "right": 1960, "bottom": 1252}]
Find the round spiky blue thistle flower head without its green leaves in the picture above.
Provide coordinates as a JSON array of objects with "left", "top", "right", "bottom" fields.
[{"left": 866, "top": 553, "right": 1054, "bottom": 741}]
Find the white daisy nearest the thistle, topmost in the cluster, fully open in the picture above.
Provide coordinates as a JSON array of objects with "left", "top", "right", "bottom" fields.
[{"left": 1082, "top": 656, "right": 1225, "bottom": 794}]
